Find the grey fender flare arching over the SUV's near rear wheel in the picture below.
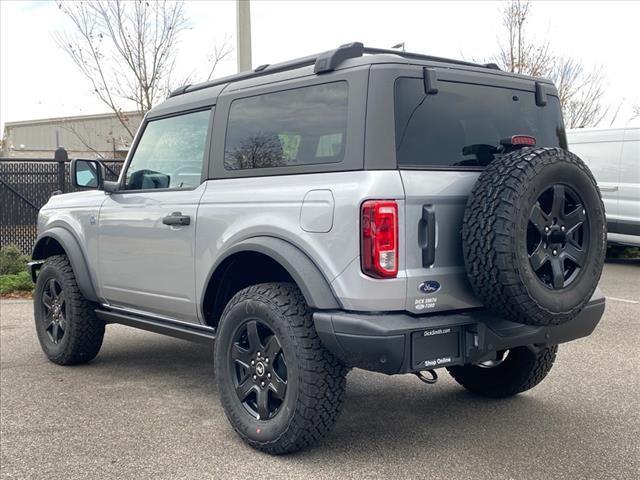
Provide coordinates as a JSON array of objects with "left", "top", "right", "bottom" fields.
[{"left": 209, "top": 236, "right": 340, "bottom": 310}]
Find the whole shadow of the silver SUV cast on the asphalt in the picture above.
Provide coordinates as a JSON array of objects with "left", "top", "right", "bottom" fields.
[{"left": 85, "top": 334, "right": 591, "bottom": 463}]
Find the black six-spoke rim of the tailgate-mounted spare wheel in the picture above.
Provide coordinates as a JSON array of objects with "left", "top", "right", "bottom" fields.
[{"left": 527, "top": 184, "right": 589, "bottom": 290}]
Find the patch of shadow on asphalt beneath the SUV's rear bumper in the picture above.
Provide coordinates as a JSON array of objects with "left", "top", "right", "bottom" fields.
[{"left": 312, "top": 376, "right": 566, "bottom": 460}]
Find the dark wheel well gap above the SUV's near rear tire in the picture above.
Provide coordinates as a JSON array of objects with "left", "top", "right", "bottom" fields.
[{"left": 203, "top": 252, "right": 295, "bottom": 327}]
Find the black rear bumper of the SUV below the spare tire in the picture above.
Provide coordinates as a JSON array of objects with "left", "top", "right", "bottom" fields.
[{"left": 313, "top": 290, "right": 605, "bottom": 375}]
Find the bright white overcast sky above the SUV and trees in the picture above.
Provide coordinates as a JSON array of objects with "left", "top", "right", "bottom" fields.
[{"left": 0, "top": 0, "right": 640, "bottom": 129}]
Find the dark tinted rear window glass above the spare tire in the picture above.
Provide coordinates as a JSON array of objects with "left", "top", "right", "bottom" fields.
[{"left": 394, "top": 78, "right": 566, "bottom": 168}]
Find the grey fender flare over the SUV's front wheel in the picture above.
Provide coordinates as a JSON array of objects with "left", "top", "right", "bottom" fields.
[{"left": 31, "top": 227, "right": 99, "bottom": 302}]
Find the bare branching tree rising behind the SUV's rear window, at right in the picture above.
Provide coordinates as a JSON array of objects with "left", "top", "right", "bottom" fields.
[{"left": 493, "top": 0, "right": 610, "bottom": 128}]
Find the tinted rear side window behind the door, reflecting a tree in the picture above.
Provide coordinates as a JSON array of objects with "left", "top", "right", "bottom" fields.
[{"left": 224, "top": 82, "right": 347, "bottom": 170}]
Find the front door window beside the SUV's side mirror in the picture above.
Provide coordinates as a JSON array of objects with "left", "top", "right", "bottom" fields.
[{"left": 125, "top": 110, "right": 211, "bottom": 190}]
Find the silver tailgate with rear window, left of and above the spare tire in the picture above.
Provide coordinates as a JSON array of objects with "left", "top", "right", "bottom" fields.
[{"left": 394, "top": 75, "right": 566, "bottom": 313}]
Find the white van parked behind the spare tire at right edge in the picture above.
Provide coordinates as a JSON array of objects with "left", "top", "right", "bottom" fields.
[{"left": 567, "top": 127, "right": 640, "bottom": 246}]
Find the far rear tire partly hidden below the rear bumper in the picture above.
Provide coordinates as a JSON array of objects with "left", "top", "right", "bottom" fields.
[{"left": 447, "top": 345, "right": 558, "bottom": 398}]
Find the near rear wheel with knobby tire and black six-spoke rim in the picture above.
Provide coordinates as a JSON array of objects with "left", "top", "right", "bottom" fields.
[{"left": 213, "top": 282, "right": 347, "bottom": 455}]
